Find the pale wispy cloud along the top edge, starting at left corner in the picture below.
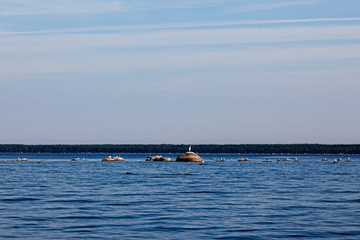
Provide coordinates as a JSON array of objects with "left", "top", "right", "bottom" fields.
[{"left": 0, "top": 0, "right": 318, "bottom": 16}]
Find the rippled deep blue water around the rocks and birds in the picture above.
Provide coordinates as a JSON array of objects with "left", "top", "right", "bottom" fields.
[{"left": 0, "top": 154, "right": 360, "bottom": 239}]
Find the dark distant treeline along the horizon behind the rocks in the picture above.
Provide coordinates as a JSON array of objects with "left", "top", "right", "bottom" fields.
[{"left": 0, "top": 144, "right": 360, "bottom": 154}]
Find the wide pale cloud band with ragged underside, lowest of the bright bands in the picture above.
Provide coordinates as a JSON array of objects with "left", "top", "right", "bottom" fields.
[{"left": 0, "top": 45, "right": 360, "bottom": 82}]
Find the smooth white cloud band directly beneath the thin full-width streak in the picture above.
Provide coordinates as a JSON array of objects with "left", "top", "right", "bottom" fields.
[{"left": 0, "top": 25, "right": 360, "bottom": 53}]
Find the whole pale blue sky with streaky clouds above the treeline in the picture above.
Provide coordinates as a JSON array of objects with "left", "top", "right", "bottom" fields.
[{"left": 0, "top": 0, "right": 360, "bottom": 144}]
